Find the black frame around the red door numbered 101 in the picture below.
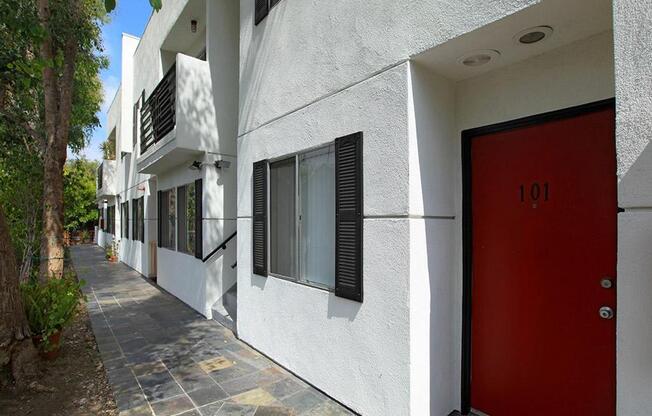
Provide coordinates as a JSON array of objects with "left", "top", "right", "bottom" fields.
[{"left": 461, "top": 98, "right": 619, "bottom": 415}]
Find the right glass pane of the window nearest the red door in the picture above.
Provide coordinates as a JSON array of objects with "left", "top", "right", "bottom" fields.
[{"left": 299, "top": 146, "right": 335, "bottom": 288}]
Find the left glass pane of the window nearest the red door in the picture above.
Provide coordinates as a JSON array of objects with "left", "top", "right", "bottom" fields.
[{"left": 269, "top": 157, "right": 297, "bottom": 277}]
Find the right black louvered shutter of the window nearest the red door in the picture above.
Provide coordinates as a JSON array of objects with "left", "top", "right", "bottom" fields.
[{"left": 335, "top": 132, "right": 362, "bottom": 302}]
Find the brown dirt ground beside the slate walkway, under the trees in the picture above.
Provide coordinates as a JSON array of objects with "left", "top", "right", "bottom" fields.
[{"left": 0, "top": 305, "right": 118, "bottom": 416}]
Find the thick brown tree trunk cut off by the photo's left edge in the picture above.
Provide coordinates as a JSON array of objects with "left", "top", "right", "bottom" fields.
[{"left": 0, "top": 206, "right": 36, "bottom": 387}]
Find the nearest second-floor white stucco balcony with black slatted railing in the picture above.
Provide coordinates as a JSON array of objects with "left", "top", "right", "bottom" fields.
[{"left": 137, "top": 53, "right": 217, "bottom": 174}]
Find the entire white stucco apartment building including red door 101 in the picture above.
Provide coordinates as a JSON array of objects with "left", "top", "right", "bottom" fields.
[{"left": 98, "top": 0, "right": 652, "bottom": 416}]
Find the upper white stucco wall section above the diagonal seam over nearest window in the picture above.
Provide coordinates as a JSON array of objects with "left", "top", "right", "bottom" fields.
[{"left": 239, "top": 0, "right": 538, "bottom": 134}]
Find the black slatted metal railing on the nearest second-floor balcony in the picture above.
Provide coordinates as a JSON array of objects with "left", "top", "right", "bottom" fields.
[{"left": 140, "top": 64, "right": 177, "bottom": 155}]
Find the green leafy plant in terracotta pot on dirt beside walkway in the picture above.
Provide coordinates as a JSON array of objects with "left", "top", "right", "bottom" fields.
[{"left": 21, "top": 274, "right": 85, "bottom": 360}]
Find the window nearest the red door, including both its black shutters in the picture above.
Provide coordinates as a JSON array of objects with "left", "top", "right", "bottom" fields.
[{"left": 251, "top": 132, "right": 363, "bottom": 302}]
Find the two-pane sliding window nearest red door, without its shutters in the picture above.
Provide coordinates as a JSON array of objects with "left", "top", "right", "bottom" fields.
[{"left": 269, "top": 145, "right": 335, "bottom": 289}]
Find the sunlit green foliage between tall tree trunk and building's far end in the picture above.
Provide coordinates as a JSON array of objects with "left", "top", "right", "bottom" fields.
[{"left": 63, "top": 158, "right": 97, "bottom": 231}]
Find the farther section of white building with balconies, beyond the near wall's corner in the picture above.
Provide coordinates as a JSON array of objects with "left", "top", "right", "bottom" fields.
[{"left": 98, "top": 0, "right": 238, "bottom": 323}]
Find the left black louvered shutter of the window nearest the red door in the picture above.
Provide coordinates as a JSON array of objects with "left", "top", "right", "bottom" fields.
[{"left": 251, "top": 160, "right": 267, "bottom": 277}]
